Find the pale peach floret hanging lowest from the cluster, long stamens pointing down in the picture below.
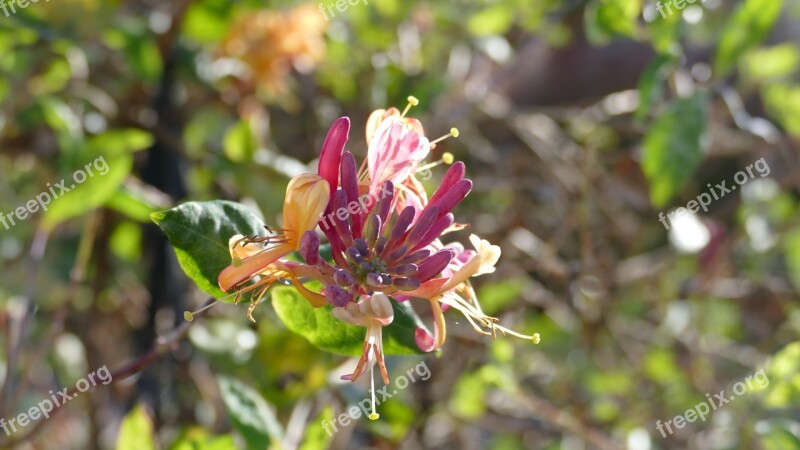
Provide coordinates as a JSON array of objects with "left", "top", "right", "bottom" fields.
[{"left": 333, "top": 292, "right": 394, "bottom": 420}]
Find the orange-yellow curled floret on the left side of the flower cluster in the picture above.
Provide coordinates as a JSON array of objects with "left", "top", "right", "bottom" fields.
[{"left": 218, "top": 174, "right": 330, "bottom": 291}]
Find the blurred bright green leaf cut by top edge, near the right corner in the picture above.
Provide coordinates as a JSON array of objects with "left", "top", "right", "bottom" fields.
[{"left": 714, "top": 0, "right": 783, "bottom": 77}]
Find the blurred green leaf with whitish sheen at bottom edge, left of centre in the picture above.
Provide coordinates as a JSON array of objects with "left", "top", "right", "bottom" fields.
[{"left": 217, "top": 376, "right": 283, "bottom": 450}]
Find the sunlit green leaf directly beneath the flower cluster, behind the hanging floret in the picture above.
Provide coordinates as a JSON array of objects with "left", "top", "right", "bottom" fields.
[{"left": 272, "top": 286, "right": 424, "bottom": 355}]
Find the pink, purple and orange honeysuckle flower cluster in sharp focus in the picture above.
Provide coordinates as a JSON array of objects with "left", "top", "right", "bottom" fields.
[{"left": 214, "top": 97, "right": 539, "bottom": 419}]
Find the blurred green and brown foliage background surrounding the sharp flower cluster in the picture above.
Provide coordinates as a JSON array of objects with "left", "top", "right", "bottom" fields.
[{"left": 0, "top": 0, "right": 800, "bottom": 450}]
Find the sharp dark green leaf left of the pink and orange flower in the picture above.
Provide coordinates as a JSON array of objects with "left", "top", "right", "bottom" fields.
[{"left": 150, "top": 200, "right": 264, "bottom": 298}]
